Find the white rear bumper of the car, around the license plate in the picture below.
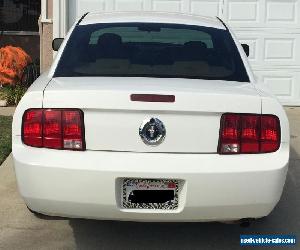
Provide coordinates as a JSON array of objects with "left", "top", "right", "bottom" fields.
[{"left": 13, "top": 137, "right": 289, "bottom": 221}]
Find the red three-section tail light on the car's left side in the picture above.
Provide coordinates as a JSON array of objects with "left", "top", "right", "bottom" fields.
[{"left": 22, "top": 109, "right": 85, "bottom": 151}]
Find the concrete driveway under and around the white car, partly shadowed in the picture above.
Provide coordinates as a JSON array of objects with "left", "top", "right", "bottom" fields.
[{"left": 0, "top": 108, "right": 300, "bottom": 250}]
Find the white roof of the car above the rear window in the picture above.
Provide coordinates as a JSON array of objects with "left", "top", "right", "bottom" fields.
[{"left": 79, "top": 11, "right": 226, "bottom": 30}]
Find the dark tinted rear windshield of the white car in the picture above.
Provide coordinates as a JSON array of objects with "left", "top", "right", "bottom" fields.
[{"left": 54, "top": 23, "right": 249, "bottom": 82}]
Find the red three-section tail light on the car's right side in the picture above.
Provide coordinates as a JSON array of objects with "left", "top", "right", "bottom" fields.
[{"left": 218, "top": 114, "right": 280, "bottom": 154}]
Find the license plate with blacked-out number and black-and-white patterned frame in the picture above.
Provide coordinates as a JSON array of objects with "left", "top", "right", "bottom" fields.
[{"left": 122, "top": 179, "right": 178, "bottom": 210}]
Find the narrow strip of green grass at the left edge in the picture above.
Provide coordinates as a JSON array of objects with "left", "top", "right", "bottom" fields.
[{"left": 0, "top": 116, "right": 12, "bottom": 165}]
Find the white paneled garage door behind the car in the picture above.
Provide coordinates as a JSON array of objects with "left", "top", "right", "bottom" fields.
[{"left": 69, "top": 0, "right": 300, "bottom": 105}]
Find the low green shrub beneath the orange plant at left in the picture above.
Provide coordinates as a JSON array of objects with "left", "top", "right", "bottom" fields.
[{"left": 0, "top": 84, "right": 27, "bottom": 105}]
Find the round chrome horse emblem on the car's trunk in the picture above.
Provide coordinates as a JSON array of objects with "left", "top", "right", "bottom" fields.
[{"left": 139, "top": 118, "right": 166, "bottom": 146}]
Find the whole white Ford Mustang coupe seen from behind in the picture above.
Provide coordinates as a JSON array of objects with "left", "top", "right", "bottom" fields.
[{"left": 12, "top": 13, "right": 289, "bottom": 221}]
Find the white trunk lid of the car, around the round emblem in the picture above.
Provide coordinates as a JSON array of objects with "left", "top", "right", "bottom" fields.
[{"left": 43, "top": 77, "right": 261, "bottom": 153}]
